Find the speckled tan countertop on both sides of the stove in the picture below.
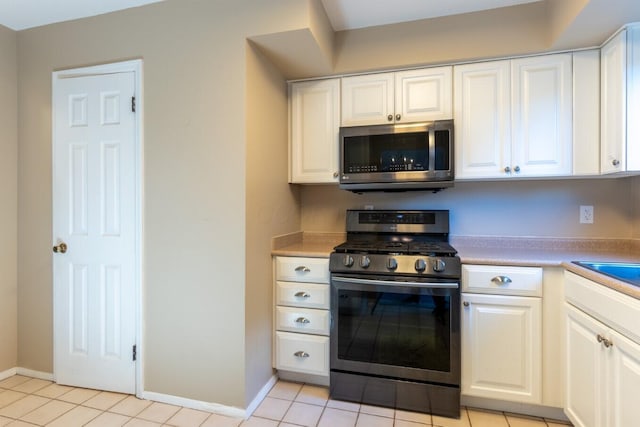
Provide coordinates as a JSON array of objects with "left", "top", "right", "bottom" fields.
[{"left": 271, "top": 232, "right": 640, "bottom": 299}]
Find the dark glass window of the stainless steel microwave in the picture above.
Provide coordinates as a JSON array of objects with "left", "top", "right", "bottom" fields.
[{"left": 344, "top": 132, "right": 428, "bottom": 173}]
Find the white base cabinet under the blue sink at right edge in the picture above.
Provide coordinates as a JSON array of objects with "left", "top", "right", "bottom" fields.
[{"left": 565, "top": 273, "right": 640, "bottom": 427}]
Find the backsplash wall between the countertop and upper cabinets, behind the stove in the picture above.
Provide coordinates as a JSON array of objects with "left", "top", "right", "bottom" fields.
[{"left": 302, "top": 178, "right": 640, "bottom": 239}]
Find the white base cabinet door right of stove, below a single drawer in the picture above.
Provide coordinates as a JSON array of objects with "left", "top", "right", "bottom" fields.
[{"left": 462, "top": 293, "right": 542, "bottom": 404}]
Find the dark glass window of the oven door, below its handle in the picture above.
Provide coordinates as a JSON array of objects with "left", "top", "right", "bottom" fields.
[{"left": 337, "top": 289, "right": 451, "bottom": 372}]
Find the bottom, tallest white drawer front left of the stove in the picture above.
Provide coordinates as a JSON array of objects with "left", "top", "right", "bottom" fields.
[{"left": 276, "top": 331, "right": 329, "bottom": 376}]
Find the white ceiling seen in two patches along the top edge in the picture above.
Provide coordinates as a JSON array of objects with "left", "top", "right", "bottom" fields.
[{"left": 0, "top": 0, "right": 541, "bottom": 31}]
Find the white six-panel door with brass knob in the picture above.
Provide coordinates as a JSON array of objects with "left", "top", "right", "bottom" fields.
[{"left": 53, "top": 65, "right": 139, "bottom": 393}]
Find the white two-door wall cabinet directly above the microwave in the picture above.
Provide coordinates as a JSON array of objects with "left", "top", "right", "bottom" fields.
[{"left": 341, "top": 66, "right": 452, "bottom": 126}]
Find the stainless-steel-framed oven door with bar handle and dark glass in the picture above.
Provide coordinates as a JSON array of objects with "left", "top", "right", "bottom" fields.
[{"left": 330, "top": 274, "right": 460, "bottom": 385}]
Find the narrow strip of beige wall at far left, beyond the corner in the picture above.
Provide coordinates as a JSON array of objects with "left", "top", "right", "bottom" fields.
[{"left": 0, "top": 26, "right": 18, "bottom": 372}]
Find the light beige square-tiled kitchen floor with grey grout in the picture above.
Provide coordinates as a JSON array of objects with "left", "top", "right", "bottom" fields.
[{"left": 0, "top": 375, "right": 566, "bottom": 427}]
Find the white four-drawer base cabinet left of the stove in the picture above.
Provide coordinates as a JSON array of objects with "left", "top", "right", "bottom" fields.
[{"left": 274, "top": 257, "right": 330, "bottom": 385}]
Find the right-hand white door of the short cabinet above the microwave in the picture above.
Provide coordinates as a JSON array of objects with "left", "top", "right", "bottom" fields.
[{"left": 395, "top": 67, "right": 453, "bottom": 123}]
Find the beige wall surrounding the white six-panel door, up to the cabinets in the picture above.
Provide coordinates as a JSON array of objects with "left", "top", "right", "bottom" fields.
[{"left": 18, "top": 0, "right": 309, "bottom": 407}]
